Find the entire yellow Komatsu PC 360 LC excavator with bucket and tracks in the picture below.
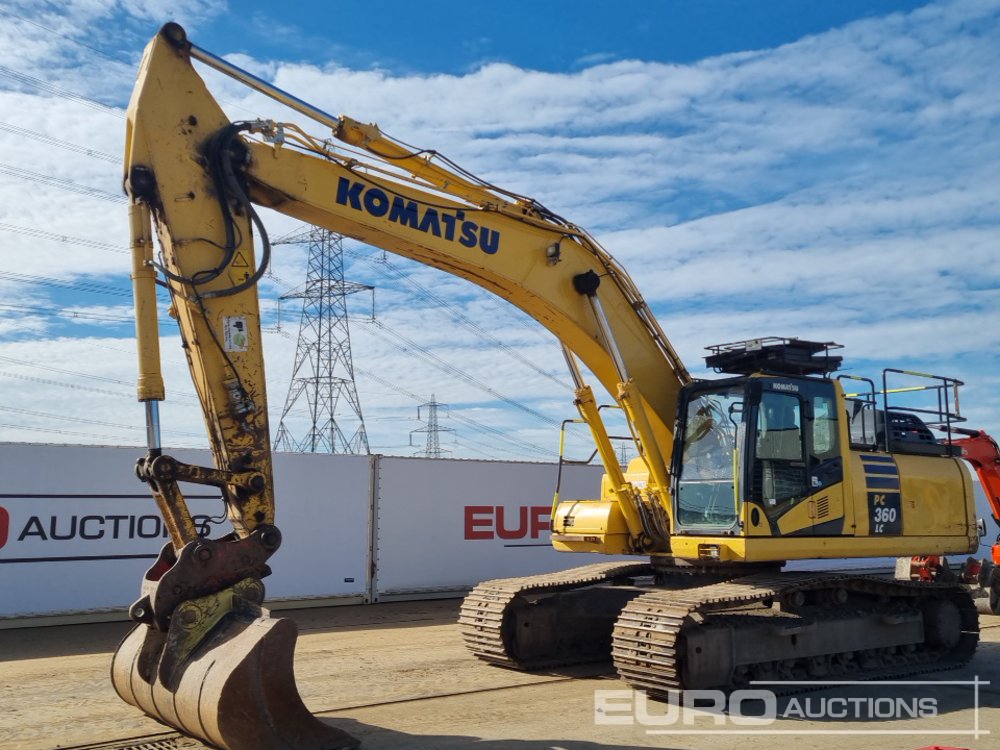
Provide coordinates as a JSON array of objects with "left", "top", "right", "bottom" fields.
[{"left": 112, "top": 24, "right": 1000, "bottom": 750}]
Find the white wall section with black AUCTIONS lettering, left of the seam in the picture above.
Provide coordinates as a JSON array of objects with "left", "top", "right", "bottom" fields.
[{"left": 0, "top": 444, "right": 371, "bottom": 617}]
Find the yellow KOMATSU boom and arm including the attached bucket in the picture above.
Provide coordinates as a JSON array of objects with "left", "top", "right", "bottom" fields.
[{"left": 112, "top": 24, "right": 690, "bottom": 750}]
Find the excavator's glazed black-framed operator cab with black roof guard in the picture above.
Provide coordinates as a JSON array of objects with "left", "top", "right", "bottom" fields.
[{"left": 672, "top": 339, "right": 843, "bottom": 534}]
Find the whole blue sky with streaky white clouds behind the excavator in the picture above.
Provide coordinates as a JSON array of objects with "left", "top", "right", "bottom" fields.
[{"left": 0, "top": 0, "right": 1000, "bottom": 459}]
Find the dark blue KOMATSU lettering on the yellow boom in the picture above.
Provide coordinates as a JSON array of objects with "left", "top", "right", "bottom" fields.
[{"left": 336, "top": 177, "right": 500, "bottom": 255}]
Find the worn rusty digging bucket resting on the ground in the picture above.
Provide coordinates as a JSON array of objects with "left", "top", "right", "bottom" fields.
[{"left": 111, "top": 597, "right": 359, "bottom": 750}]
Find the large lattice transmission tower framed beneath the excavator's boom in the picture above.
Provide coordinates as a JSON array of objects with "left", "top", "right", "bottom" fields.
[{"left": 274, "top": 229, "right": 372, "bottom": 454}]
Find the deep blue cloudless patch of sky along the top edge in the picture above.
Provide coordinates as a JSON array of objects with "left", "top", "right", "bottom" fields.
[{"left": 178, "top": 0, "right": 922, "bottom": 74}]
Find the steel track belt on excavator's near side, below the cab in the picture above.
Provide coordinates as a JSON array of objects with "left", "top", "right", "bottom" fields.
[{"left": 612, "top": 573, "right": 979, "bottom": 696}]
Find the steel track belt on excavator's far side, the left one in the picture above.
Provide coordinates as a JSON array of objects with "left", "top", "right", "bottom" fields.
[{"left": 458, "top": 562, "right": 653, "bottom": 669}]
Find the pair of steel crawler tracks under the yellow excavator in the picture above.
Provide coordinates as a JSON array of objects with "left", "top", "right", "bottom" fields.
[{"left": 459, "top": 564, "right": 979, "bottom": 696}]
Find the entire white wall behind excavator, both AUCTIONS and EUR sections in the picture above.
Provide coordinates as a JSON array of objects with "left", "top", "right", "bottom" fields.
[{"left": 0, "top": 443, "right": 601, "bottom": 618}]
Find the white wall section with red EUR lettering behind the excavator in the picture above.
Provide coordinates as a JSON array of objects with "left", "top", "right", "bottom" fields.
[{"left": 373, "top": 457, "right": 608, "bottom": 597}]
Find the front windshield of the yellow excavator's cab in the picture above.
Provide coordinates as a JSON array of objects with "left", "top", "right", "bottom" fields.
[{"left": 675, "top": 387, "right": 745, "bottom": 530}]
